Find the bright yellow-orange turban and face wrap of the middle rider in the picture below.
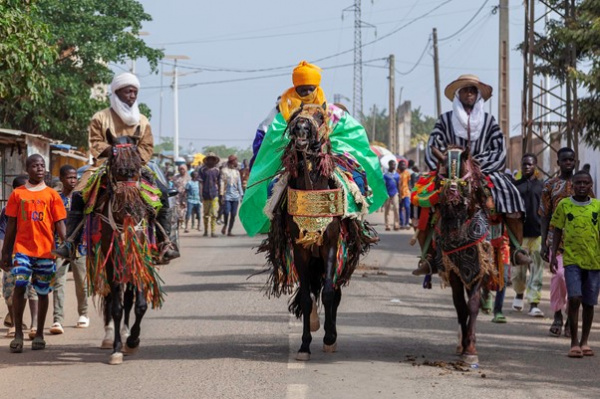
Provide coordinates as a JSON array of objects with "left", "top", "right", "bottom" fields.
[{"left": 279, "top": 61, "right": 327, "bottom": 121}]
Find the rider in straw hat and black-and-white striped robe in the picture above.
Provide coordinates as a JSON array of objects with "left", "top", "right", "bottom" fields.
[{"left": 413, "top": 75, "right": 530, "bottom": 275}]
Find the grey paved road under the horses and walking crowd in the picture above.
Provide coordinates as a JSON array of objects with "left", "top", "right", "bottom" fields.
[{"left": 0, "top": 214, "right": 600, "bottom": 399}]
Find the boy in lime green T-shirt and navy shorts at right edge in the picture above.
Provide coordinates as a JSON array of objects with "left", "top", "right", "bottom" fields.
[{"left": 550, "top": 171, "right": 600, "bottom": 357}]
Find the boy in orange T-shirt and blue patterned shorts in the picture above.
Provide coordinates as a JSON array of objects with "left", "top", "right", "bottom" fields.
[{"left": 0, "top": 154, "right": 67, "bottom": 353}]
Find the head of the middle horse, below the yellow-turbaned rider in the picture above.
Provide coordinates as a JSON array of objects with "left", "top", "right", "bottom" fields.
[{"left": 288, "top": 104, "right": 329, "bottom": 153}]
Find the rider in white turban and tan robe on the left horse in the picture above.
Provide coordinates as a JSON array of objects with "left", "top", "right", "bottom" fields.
[{"left": 54, "top": 72, "right": 180, "bottom": 261}]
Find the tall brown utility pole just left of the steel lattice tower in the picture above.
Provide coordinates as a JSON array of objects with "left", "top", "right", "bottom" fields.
[{"left": 498, "top": 0, "right": 512, "bottom": 168}]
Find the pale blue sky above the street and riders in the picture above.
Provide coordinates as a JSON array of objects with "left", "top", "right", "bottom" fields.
[{"left": 125, "top": 0, "right": 524, "bottom": 153}]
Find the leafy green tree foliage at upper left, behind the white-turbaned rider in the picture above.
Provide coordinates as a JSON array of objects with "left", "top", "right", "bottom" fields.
[{"left": 0, "top": 0, "right": 162, "bottom": 146}]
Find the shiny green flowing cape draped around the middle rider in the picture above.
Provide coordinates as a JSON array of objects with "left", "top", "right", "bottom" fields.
[{"left": 240, "top": 113, "right": 388, "bottom": 237}]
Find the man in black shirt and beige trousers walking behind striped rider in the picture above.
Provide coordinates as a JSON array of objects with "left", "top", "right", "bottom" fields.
[{"left": 511, "top": 154, "right": 544, "bottom": 317}]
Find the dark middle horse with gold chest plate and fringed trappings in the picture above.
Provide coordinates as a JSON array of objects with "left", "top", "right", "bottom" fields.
[{"left": 259, "top": 105, "right": 377, "bottom": 360}]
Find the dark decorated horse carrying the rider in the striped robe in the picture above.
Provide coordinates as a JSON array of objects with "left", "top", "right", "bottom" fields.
[{"left": 432, "top": 148, "right": 495, "bottom": 364}]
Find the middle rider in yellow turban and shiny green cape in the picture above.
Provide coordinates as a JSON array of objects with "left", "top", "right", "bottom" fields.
[{"left": 240, "top": 61, "right": 388, "bottom": 236}]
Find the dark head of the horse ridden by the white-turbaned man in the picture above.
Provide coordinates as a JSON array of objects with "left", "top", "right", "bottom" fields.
[{"left": 106, "top": 126, "right": 142, "bottom": 181}]
